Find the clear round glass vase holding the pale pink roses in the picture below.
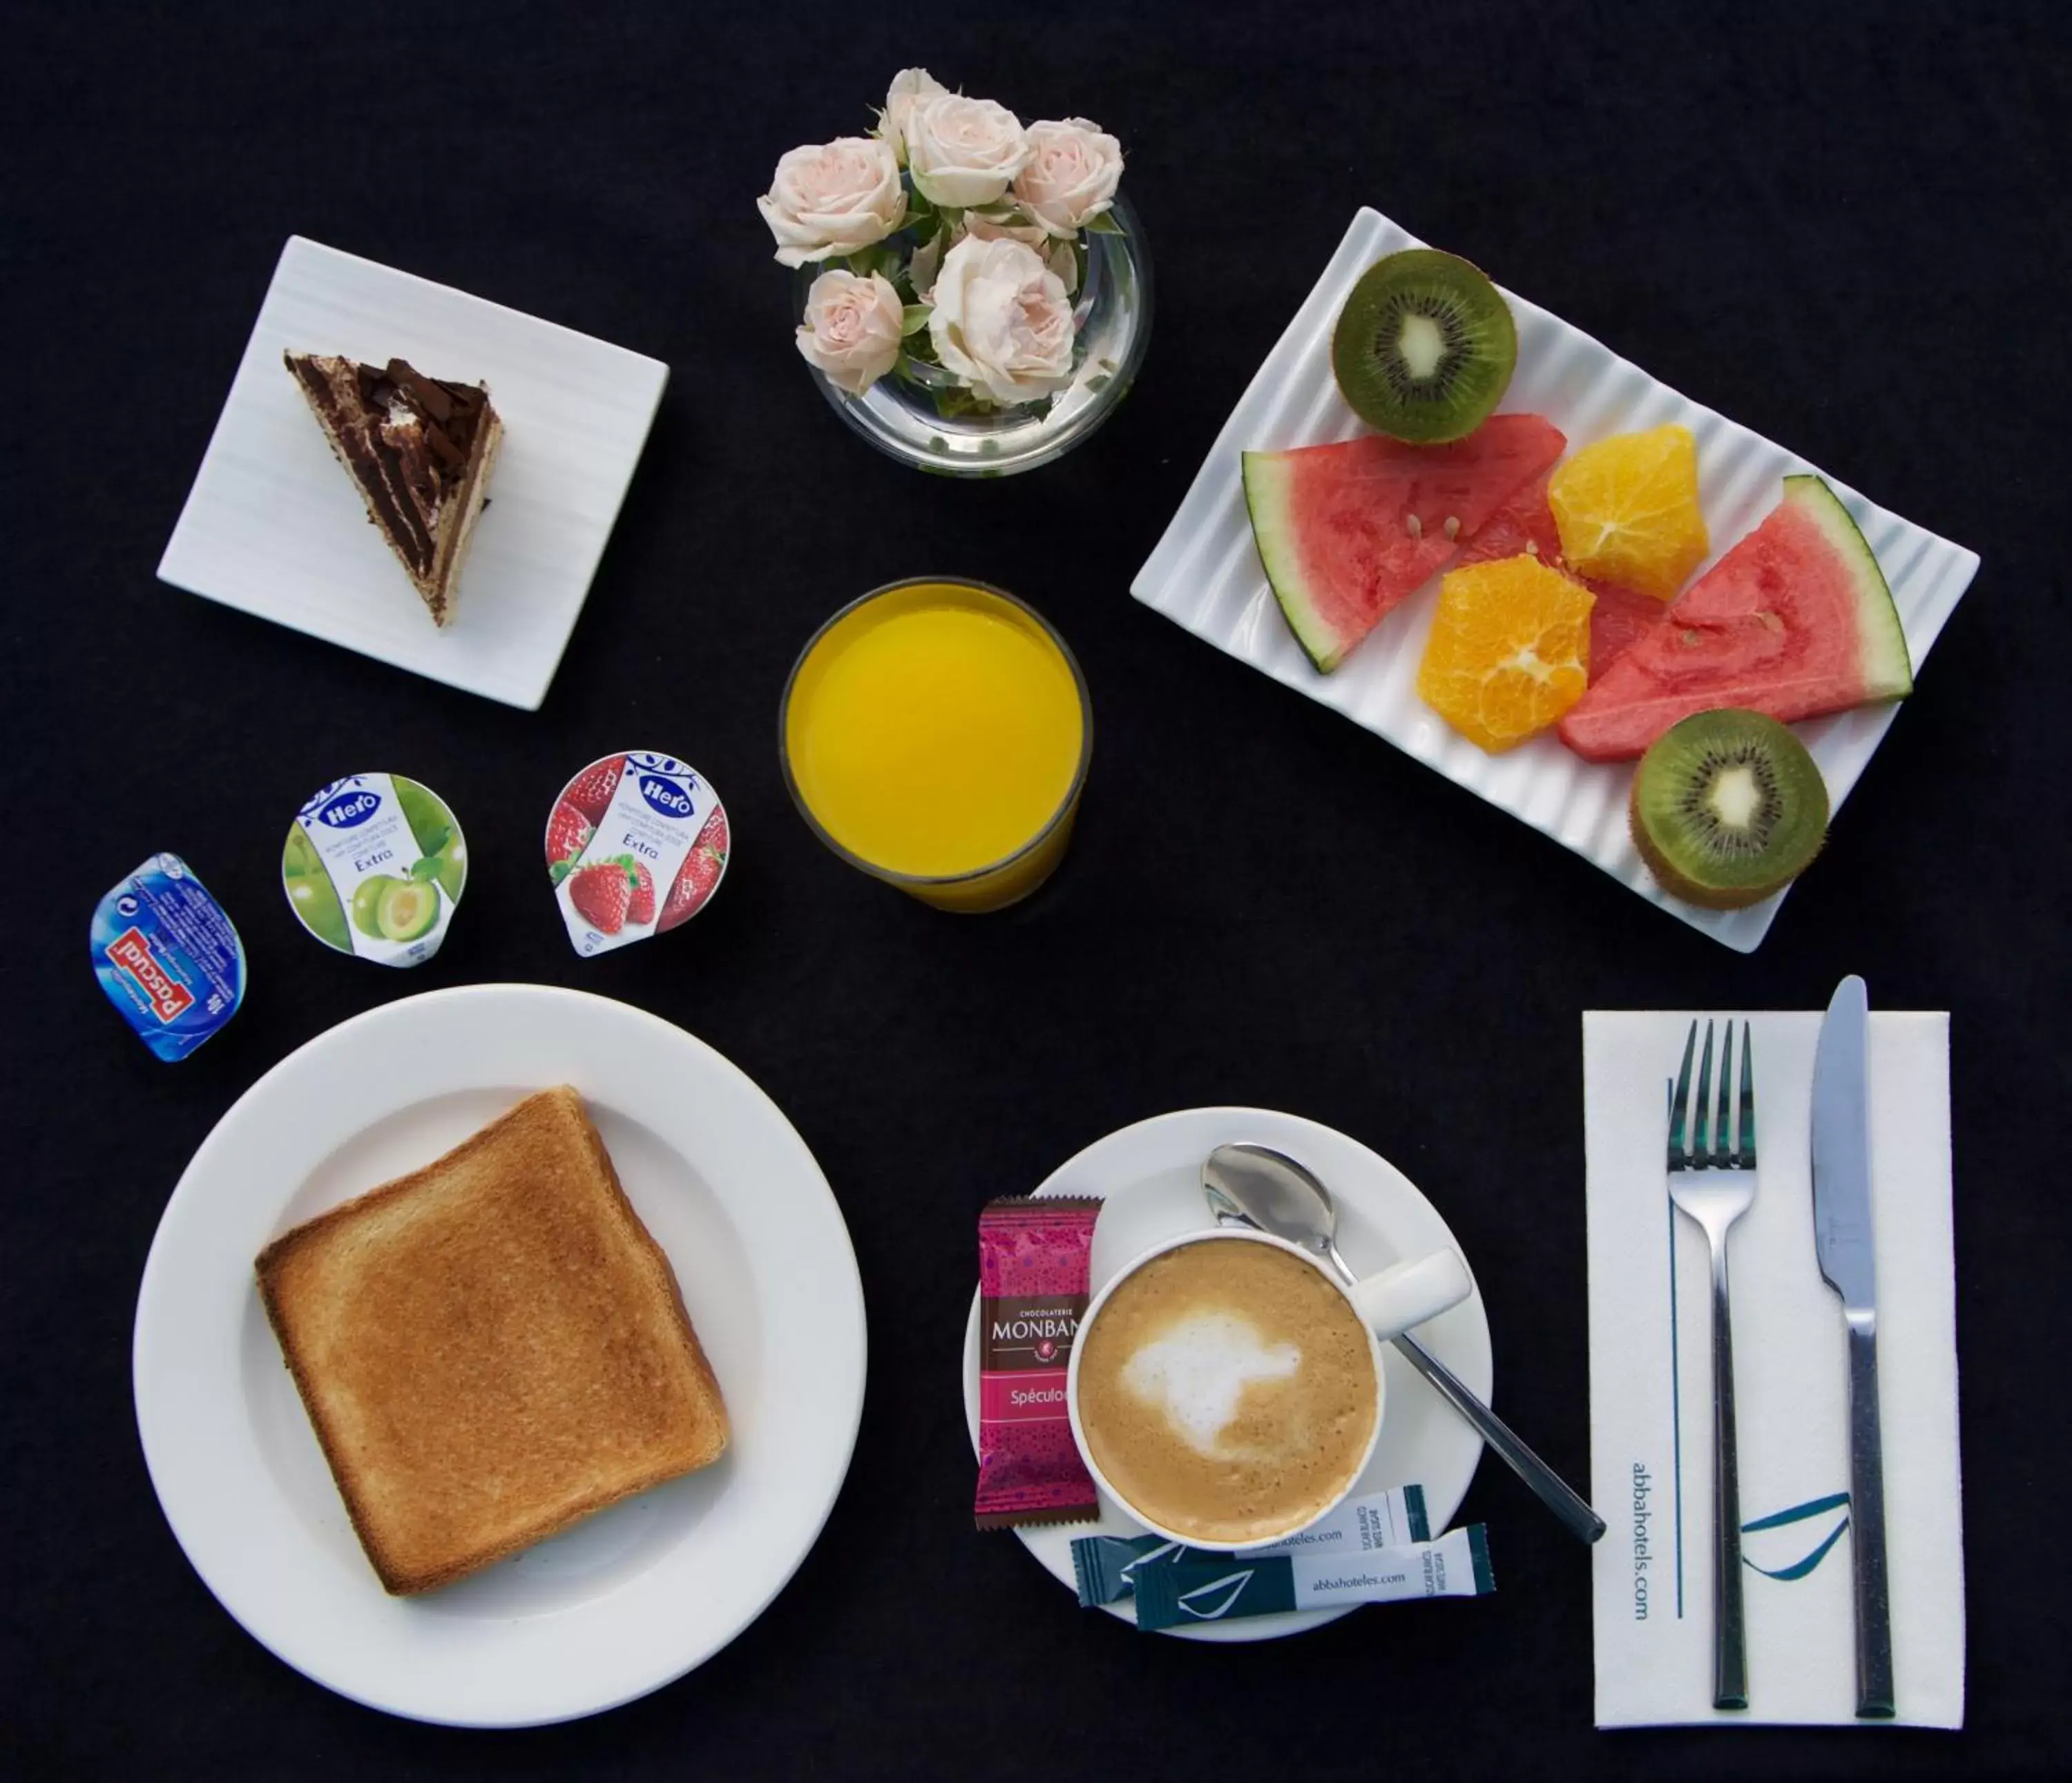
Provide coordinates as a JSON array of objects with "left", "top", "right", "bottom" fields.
[{"left": 796, "top": 197, "right": 1152, "bottom": 476}]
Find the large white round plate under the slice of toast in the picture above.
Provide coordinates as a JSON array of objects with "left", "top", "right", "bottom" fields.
[{"left": 133, "top": 983, "right": 864, "bottom": 1727}]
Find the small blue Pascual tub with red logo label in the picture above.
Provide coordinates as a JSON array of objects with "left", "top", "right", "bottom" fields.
[{"left": 89, "top": 856, "right": 244, "bottom": 1062}]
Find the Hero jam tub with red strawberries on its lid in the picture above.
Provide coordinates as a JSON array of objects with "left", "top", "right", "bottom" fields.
[{"left": 545, "top": 750, "right": 731, "bottom": 956}]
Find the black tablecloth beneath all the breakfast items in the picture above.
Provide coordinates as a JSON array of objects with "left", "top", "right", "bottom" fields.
[{"left": 0, "top": 4, "right": 2072, "bottom": 1777}]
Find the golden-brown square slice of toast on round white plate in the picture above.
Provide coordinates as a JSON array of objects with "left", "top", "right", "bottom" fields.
[{"left": 257, "top": 1085, "right": 727, "bottom": 1594}]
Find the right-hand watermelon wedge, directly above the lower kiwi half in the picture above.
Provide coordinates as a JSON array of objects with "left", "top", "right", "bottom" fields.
[{"left": 1560, "top": 476, "right": 1915, "bottom": 762}]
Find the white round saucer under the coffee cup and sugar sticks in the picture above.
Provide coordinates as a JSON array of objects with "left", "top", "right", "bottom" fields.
[{"left": 963, "top": 1108, "right": 1490, "bottom": 1640}]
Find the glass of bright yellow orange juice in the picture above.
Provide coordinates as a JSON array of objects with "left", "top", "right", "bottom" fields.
[{"left": 777, "top": 576, "right": 1094, "bottom": 911}]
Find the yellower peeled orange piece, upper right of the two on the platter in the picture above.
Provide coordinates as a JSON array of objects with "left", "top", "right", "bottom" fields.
[{"left": 1548, "top": 427, "right": 1711, "bottom": 601}]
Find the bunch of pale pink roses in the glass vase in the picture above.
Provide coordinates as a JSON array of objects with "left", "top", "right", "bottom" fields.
[{"left": 756, "top": 68, "right": 1123, "bottom": 416}]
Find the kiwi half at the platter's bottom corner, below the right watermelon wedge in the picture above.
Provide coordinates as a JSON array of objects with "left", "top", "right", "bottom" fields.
[{"left": 1627, "top": 706, "right": 1828, "bottom": 909}]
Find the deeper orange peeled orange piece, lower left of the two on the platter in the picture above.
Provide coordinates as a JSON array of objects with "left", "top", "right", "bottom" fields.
[{"left": 1417, "top": 557, "right": 1595, "bottom": 756}]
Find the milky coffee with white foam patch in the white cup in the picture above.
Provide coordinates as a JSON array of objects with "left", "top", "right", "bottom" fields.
[{"left": 1080, "top": 1238, "right": 1380, "bottom": 1543}]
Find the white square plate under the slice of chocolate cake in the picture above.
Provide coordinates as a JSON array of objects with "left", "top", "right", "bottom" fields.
[{"left": 157, "top": 236, "right": 669, "bottom": 711}]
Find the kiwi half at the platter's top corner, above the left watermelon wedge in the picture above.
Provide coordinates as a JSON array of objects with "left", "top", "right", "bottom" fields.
[{"left": 1330, "top": 249, "right": 1519, "bottom": 445}]
